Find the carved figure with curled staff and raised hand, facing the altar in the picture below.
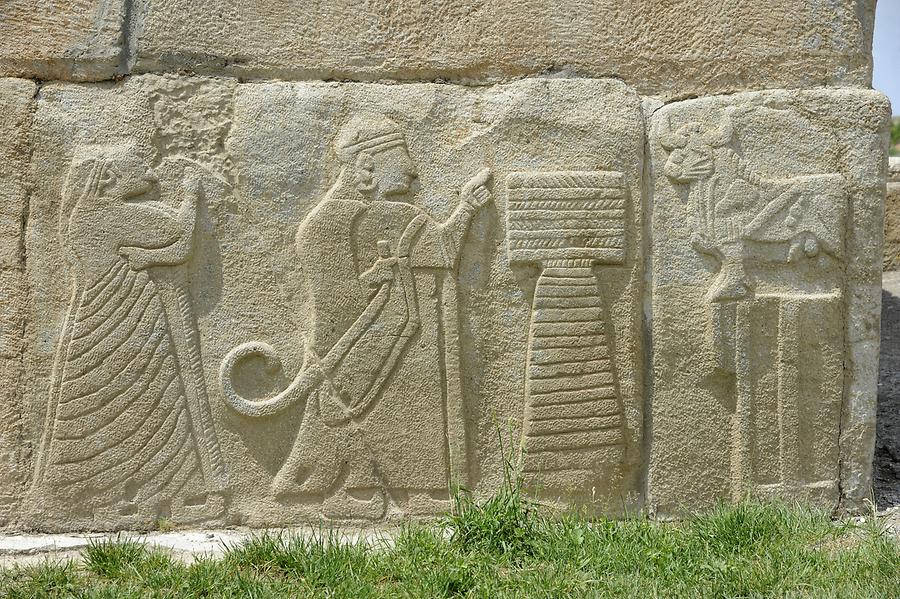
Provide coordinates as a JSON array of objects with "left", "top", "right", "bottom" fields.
[{"left": 221, "top": 118, "right": 490, "bottom": 518}]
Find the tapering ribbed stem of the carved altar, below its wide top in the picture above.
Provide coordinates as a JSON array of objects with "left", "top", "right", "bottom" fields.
[{"left": 522, "top": 260, "right": 624, "bottom": 478}]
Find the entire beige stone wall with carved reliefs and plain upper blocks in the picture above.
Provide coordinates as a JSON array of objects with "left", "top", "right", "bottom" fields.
[{"left": 0, "top": 0, "right": 890, "bottom": 530}]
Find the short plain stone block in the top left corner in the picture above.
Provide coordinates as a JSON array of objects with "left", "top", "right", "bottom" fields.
[{"left": 0, "top": 0, "right": 126, "bottom": 81}]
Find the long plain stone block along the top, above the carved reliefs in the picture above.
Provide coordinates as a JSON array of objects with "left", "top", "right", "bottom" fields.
[{"left": 130, "top": 0, "right": 875, "bottom": 97}]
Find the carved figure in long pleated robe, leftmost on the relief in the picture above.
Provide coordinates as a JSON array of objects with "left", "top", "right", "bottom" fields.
[{"left": 32, "top": 145, "right": 223, "bottom": 523}]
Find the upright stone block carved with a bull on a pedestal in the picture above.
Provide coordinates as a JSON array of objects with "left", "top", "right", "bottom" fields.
[{"left": 648, "top": 90, "right": 890, "bottom": 513}]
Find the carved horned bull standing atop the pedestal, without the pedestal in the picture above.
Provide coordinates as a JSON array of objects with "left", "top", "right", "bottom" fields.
[{"left": 658, "top": 112, "right": 845, "bottom": 302}]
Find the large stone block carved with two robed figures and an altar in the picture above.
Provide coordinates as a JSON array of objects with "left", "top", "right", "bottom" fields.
[{"left": 16, "top": 76, "right": 644, "bottom": 529}]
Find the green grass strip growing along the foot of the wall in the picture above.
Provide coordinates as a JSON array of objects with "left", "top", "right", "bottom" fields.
[{"left": 0, "top": 476, "right": 900, "bottom": 599}]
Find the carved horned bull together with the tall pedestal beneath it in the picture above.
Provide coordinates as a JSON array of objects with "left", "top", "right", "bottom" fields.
[{"left": 656, "top": 111, "right": 847, "bottom": 501}]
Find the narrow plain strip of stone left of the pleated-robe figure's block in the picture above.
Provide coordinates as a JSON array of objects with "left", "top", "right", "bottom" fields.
[{"left": 0, "top": 79, "right": 35, "bottom": 526}]
